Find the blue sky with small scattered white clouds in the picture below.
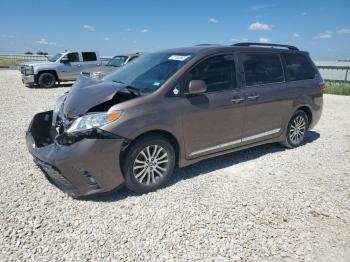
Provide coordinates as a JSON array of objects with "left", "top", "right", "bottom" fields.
[{"left": 0, "top": 0, "right": 350, "bottom": 60}]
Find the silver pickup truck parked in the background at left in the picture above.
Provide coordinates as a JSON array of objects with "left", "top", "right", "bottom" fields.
[{"left": 20, "top": 51, "right": 102, "bottom": 88}]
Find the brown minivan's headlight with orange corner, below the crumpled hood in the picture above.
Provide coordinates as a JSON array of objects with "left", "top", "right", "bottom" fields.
[{"left": 67, "top": 111, "right": 122, "bottom": 134}]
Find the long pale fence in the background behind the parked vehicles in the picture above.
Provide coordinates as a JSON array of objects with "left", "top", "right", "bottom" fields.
[{"left": 0, "top": 54, "right": 350, "bottom": 82}]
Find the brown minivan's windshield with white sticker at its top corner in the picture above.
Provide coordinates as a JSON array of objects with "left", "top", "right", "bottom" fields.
[{"left": 103, "top": 52, "right": 192, "bottom": 94}]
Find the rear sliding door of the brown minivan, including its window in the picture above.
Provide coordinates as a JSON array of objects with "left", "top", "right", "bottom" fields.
[{"left": 239, "top": 52, "right": 293, "bottom": 144}]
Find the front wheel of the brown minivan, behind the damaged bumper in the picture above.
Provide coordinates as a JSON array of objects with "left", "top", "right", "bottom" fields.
[{"left": 122, "top": 136, "right": 175, "bottom": 193}]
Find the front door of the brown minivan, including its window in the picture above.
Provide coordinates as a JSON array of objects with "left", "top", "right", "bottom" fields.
[{"left": 182, "top": 54, "right": 244, "bottom": 158}]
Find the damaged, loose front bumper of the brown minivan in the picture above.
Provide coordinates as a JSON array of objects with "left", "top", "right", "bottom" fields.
[{"left": 26, "top": 111, "right": 125, "bottom": 197}]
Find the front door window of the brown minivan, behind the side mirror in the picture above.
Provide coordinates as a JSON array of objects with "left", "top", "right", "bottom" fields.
[{"left": 187, "top": 55, "right": 236, "bottom": 93}]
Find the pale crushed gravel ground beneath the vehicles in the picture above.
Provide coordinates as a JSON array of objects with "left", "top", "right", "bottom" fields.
[{"left": 0, "top": 70, "right": 350, "bottom": 261}]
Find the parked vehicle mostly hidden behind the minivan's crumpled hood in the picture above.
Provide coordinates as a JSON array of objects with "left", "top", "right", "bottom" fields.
[{"left": 84, "top": 53, "right": 142, "bottom": 79}]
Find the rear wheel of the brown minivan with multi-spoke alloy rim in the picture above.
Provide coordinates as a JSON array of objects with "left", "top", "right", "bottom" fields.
[{"left": 282, "top": 110, "right": 309, "bottom": 148}]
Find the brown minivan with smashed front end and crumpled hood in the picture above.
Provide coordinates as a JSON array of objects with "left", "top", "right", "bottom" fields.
[{"left": 26, "top": 43, "right": 325, "bottom": 197}]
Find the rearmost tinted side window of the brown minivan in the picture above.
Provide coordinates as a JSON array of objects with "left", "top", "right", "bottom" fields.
[{"left": 282, "top": 54, "right": 316, "bottom": 81}]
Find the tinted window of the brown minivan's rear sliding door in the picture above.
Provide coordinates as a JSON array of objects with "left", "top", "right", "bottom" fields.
[{"left": 241, "top": 53, "right": 284, "bottom": 86}]
